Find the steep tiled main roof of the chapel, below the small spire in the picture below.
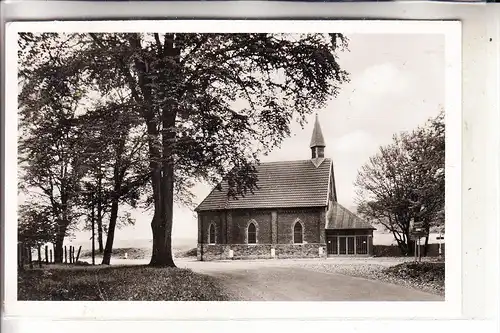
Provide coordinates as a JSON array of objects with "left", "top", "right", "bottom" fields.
[{"left": 196, "top": 158, "right": 332, "bottom": 211}]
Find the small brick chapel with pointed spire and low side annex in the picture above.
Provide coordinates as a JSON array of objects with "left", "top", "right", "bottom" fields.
[{"left": 195, "top": 115, "right": 375, "bottom": 260}]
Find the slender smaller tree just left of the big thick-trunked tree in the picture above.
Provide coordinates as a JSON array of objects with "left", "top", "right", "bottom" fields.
[{"left": 74, "top": 97, "right": 149, "bottom": 264}]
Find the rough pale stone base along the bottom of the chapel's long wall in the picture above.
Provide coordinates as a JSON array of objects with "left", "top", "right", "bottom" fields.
[{"left": 197, "top": 244, "right": 326, "bottom": 261}]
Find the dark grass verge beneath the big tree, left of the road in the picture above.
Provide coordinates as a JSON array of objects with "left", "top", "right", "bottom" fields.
[{"left": 18, "top": 266, "right": 229, "bottom": 301}]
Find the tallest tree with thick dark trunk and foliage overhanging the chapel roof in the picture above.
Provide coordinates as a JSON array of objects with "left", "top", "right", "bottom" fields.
[{"left": 20, "top": 33, "right": 348, "bottom": 266}]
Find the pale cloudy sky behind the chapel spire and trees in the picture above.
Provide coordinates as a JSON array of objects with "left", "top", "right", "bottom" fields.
[{"left": 65, "top": 33, "right": 445, "bottom": 247}]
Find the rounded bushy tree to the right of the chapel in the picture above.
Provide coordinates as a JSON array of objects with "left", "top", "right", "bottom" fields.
[{"left": 355, "top": 111, "right": 445, "bottom": 255}]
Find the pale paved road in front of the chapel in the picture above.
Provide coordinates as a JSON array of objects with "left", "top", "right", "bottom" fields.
[{"left": 179, "top": 262, "right": 444, "bottom": 301}]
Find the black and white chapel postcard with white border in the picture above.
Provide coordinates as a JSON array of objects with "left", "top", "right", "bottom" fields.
[{"left": 5, "top": 20, "right": 462, "bottom": 319}]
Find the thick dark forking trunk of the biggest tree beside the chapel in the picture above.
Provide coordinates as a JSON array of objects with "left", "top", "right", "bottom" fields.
[{"left": 127, "top": 34, "right": 180, "bottom": 267}]
